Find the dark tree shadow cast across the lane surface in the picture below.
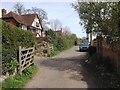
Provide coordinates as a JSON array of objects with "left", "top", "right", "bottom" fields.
[{"left": 35, "top": 50, "right": 96, "bottom": 88}]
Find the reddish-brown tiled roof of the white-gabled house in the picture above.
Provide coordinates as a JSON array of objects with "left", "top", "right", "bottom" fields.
[{"left": 2, "top": 12, "right": 37, "bottom": 26}]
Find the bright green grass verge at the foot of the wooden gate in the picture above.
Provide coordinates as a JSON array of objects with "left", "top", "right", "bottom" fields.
[{"left": 2, "top": 65, "right": 37, "bottom": 90}]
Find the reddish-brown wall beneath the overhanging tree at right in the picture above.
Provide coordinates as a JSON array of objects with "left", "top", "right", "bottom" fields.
[{"left": 97, "top": 38, "right": 120, "bottom": 72}]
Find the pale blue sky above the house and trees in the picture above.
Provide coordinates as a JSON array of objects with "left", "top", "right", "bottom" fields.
[{"left": 0, "top": 0, "right": 86, "bottom": 38}]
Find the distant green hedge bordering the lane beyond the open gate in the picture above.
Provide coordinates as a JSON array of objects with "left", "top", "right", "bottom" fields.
[{"left": 46, "top": 29, "right": 77, "bottom": 56}]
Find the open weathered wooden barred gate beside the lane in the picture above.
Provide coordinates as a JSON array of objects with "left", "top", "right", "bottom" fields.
[{"left": 19, "top": 46, "right": 34, "bottom": 74}]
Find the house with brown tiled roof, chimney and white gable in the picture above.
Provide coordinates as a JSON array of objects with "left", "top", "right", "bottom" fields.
[{"left": 2, "top": 9, "right": 45, "bottom": 38}]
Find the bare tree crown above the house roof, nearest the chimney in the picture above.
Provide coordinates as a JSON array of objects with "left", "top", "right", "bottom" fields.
[{"left": 14, "top": 2, "right": 25, "bottom": 15}]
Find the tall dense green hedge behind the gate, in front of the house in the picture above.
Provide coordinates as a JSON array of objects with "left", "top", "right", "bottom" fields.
[{"left": 1, "top": 21, "right": 35, "bottom": 74}]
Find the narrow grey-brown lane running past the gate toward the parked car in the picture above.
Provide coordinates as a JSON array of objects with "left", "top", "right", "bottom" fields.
[{"left": 25, "top": 46, "right": 95, "bottom": 88}]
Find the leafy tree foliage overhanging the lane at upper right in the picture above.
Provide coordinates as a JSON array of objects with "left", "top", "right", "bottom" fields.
[{"left": 72, "top": 1, "right": 120, "bottom": 45}]
